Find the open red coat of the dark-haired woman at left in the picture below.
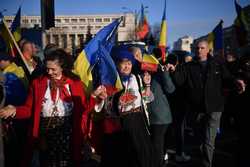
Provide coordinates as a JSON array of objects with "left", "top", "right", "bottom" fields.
[{"left": 16, "top": 76, "right": 95, "bottom": 166}]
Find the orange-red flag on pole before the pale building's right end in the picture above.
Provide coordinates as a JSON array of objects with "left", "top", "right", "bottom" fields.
[{"left": 136, "top": 5, "right": 149, "bottom": 40}]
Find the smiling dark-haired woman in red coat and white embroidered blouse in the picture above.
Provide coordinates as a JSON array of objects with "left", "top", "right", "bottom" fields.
[{"left": 0, "top": 49, "right": 106, "bottom": 167}]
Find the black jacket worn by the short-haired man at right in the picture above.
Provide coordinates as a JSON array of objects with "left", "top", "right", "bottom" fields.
[{"left": 173, "top": 56, "right": 234, "bottom": 112}]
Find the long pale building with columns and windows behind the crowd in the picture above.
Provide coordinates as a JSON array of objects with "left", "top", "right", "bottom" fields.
[{"left": 4, "top": 13, "right": 135, "bottom": 50}]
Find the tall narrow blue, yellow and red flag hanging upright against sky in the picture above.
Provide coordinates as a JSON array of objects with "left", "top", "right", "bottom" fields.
[{"left": 158, "top": 0, "right": 167, "bottom": 63}]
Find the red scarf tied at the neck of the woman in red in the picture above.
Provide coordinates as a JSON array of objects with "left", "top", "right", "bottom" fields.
[{"left": 49, "top": 76, "right": 72, "bottom": 103}]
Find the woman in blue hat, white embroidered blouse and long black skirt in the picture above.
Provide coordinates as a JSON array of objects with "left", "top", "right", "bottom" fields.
[{"left": 102, "top": 50, "right": 153, "bottom": 167}]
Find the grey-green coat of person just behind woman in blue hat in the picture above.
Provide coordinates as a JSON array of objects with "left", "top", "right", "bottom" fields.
[{"left": 148, "top": 71, "right": 175, "bottom": 124}]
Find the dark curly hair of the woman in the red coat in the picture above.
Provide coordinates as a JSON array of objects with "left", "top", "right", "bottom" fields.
[{"left": 44, "top": 49, "right": 79, "bottom": 80}]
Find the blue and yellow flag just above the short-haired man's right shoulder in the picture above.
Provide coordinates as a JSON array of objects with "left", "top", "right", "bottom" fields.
[{"left": 208, "top": 20, "right": 223, "bottom": 54}]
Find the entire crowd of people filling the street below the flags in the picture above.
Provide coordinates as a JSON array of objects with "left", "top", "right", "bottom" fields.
[{"left": 0, "top": 37, "right": 250, "bottom": 167}]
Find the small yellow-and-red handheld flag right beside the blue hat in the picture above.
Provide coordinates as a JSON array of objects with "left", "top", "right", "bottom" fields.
[{"left": 141, "top": 54, "right": 160, "bottom": 72}]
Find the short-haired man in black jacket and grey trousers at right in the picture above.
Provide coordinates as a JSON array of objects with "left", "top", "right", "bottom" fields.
[{"left": 166, "top": 41, "right": 245, "bottom": 167}]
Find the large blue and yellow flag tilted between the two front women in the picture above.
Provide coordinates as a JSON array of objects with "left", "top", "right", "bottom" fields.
[{"left": 73, "top": 19, "right": 121, "bottom": 93}]
